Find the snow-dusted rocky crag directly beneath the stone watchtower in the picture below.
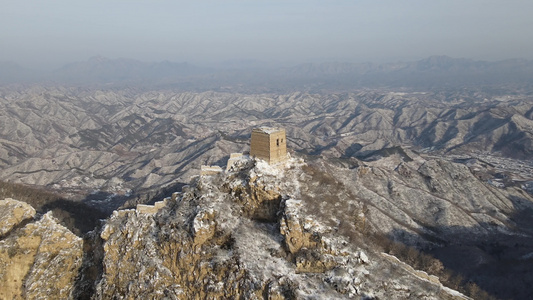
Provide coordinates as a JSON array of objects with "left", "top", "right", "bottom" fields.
[{"left": 95, "top": 158, "right": 463, "bottom": 299}]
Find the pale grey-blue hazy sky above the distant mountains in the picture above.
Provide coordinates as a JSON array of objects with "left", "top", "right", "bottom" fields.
[{"left": 0, "top": 0, "right": 533, "bottom": 67}]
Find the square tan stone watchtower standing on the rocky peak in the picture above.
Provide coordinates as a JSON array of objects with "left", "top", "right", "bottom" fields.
[{"left": 250, "top": 127, "right": 287, "bottom": 164}]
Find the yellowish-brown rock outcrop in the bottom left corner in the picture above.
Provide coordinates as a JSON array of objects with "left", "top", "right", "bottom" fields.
[{"left": 0, "top": 199, "right": 83, "bottom": 299}]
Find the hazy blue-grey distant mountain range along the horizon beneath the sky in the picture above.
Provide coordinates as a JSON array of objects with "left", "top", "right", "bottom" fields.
[{"left": 0, "top": 56, "right": 533, "bottom": 91}]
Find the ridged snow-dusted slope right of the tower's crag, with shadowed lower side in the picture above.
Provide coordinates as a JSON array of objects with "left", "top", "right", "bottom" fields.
[{"left": 314, "top": 150, "right": 533, "bottom": 299}]
